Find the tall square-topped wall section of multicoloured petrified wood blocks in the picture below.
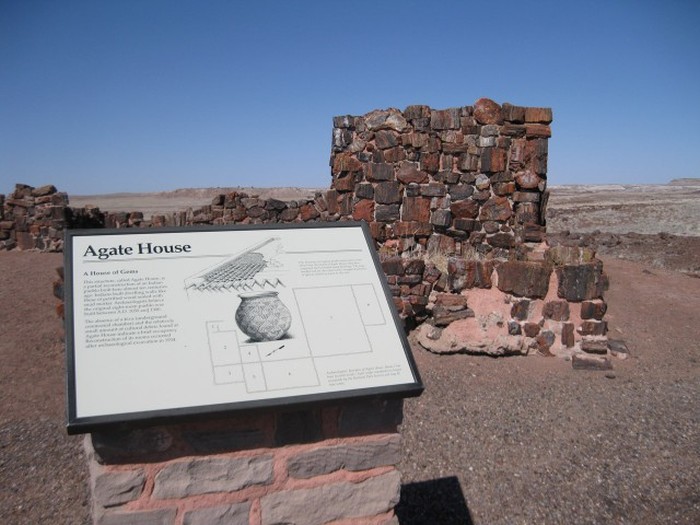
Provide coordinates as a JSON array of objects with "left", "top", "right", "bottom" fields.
[{"left": 329, "top": 99, "right": 552, "bottom": 258}]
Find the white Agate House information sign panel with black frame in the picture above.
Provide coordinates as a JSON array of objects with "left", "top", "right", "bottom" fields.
[{"left": 65, "top": 222, "right": 423, "bottom": 433}]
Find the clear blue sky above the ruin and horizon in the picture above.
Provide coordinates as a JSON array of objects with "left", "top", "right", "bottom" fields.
[{"left": 0, "top": 0, "right": 700, "bottom": 195}]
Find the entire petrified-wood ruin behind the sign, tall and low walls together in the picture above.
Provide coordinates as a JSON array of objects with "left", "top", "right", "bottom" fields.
[{"left": 0, "top": 99, "right": 610, "bottom": 366}]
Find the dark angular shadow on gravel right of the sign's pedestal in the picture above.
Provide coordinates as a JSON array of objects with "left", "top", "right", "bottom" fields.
[{"left": 396, "top": 476, "right": 474, "bottom": 525}]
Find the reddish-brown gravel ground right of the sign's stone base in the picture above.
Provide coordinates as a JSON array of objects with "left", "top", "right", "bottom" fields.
[{"left": 398, "top": 260, "right": 700, "bottom": 524}]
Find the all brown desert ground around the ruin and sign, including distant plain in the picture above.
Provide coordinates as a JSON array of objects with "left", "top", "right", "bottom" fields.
[{"left": 0, "top": 184, "right": 700, "bottom": 525}]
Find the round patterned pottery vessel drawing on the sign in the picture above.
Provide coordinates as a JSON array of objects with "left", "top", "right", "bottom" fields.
[{"left": 236, "top": 291, "right": 292, "bottom": 341}]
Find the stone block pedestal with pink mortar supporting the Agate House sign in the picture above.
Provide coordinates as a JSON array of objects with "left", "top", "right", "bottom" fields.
[{"left": 85, "top": 400, "right": 402, "bottom": 525}]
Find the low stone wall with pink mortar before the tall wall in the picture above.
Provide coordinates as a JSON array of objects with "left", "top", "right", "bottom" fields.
[{"left": 383, "top": 245, "right": 608, "bottom": 357}]
